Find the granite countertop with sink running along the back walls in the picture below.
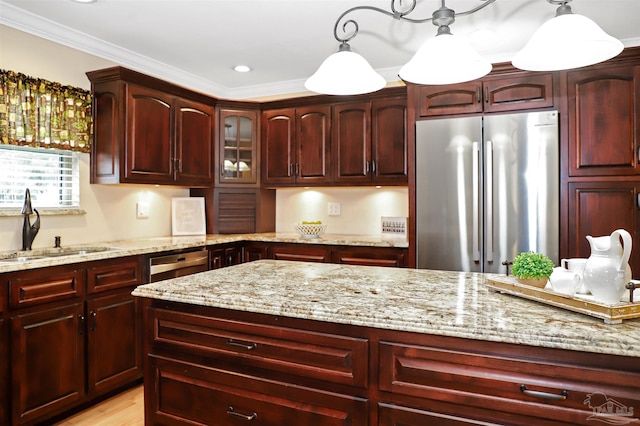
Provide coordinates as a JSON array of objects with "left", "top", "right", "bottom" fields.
[{"left": 0, "top": 232, "right": 409, "bottom": 273}]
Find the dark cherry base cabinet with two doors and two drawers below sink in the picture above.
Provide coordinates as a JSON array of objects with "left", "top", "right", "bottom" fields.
[{"left": 0, "top": 256, "right": 143, "bottom": 425}]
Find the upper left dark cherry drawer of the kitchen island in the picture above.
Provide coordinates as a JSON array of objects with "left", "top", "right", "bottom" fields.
[{"left": 148, "top": 309, "right": 369, "bottom": 388}]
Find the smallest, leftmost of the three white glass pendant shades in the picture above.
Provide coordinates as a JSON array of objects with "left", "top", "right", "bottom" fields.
[{"left": 304, "top": 43, "right": 387, "bottom": 95}]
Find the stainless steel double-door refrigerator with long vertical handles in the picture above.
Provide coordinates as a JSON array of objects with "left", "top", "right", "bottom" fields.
[{"left": 416, "top": 111, "right": 560, "bottom": 273}]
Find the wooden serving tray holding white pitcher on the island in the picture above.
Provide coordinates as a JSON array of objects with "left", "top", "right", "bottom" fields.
[{"left": 487, "top": 274, "right": 640, "bottom": 324}]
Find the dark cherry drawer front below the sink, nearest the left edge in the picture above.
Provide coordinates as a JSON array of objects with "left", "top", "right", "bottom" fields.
[{"left": 7, "top": 267, "right": 84, "bottom": 309}]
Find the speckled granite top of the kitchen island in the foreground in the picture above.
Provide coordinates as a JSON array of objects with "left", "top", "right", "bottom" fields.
[{"left": 133, "top": 260, "right": 640, "bottom": 357}]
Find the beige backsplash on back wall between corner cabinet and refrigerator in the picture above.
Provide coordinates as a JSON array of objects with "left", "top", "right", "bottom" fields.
[{"left": 276, "top": 187, "right": 409, "bottom": 235}]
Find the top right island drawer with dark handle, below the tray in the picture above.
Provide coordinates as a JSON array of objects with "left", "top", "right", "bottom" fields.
[{"left": 379, "top": 341, "right": 640, "bottom": 425}]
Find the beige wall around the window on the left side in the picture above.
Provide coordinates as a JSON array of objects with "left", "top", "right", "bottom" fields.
[{"left": 0, "top": 25, "right": 189, "bottom": 251}]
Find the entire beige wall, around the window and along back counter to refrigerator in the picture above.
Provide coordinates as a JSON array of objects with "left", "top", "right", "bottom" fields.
[{"left": 0, "top": 25, "right": 408, "bottom": 251}]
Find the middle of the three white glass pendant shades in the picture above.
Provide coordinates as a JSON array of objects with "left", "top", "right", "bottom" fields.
[{"left": 398, "top": 33, "right": 492, "bottom": 84}]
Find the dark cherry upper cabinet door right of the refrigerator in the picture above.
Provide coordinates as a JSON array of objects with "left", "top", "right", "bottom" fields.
[{"left": 567, "top": 65, "right": 640, "bottom": 176}]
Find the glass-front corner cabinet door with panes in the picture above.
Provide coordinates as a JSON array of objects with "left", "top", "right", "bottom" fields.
[{"left": 219, "top": 110, "right": 258, "bottom": 183}]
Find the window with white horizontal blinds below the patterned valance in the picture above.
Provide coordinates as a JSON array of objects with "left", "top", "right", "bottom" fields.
[{"left": 0, "top": 145, "right": 80, "bottom": 209}]
